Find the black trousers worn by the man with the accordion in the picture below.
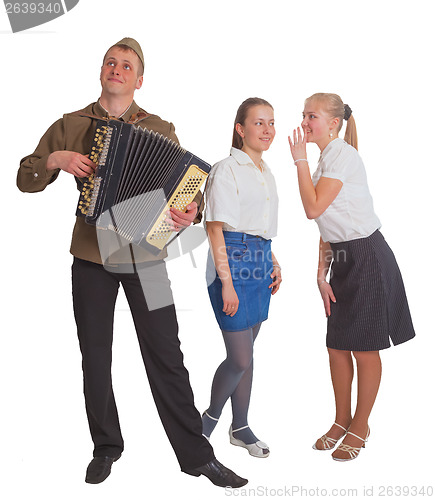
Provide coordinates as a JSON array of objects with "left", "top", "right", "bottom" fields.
[{"left": 72, "top": 258, "right": 214, "bottom": 470}]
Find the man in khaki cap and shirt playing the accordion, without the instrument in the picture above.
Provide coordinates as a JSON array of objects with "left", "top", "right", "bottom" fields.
[{"left": 17, "top": 38, "right": 247, "bottom": 487}]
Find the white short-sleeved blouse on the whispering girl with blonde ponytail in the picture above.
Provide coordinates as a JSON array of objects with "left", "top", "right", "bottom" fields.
[{"left": 313, "top": 138, "right": 381, "bottom": 243}]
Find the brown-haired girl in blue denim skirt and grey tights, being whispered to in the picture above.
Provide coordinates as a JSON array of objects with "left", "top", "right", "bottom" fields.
[{"left": 202, "top": 98, "right": 281, "bottom": 458}]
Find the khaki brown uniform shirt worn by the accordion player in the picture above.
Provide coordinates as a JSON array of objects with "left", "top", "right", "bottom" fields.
[{"left": 17, "top": 101, "right": 202, "bottom": 264}]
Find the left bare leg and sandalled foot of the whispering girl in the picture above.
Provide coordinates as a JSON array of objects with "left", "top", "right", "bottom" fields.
[{"left": 315, "top": 348, "right": 353, "bottom": 450}]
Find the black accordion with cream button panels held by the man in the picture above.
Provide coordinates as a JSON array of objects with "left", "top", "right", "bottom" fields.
[{"left": 76, "top": 120, "right": 211, "bottom": 255}]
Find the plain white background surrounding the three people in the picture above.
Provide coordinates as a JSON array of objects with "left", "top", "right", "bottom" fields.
[{"left": 0, "top": 0, "right": 435, "bottom": 500}]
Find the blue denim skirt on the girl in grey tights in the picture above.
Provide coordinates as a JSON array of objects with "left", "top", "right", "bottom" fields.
[{"left": 207, "top": 231, "right": 273, "bottom": 332}]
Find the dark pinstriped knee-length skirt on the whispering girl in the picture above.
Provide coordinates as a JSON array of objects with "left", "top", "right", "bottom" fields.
[{"left": 326, "top": 230, "right": 415, "bottom": 351}]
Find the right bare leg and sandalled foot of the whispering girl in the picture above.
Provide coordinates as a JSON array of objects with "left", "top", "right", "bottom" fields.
[{"left": 332, "top": 351, "right": 382, "bottom": 458}]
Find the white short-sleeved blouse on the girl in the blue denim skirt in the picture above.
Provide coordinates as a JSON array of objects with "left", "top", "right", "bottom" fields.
[{"left": 204, "top": 148, "right": 278, "bottom": 239}]
